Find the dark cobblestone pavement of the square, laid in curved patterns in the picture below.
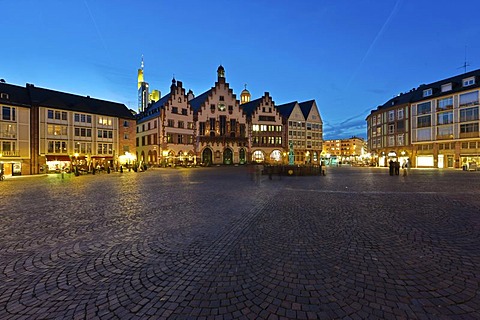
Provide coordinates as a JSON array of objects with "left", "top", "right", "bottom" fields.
[{"left": 0, "top": 167, "right": 480, "bottom": 319}]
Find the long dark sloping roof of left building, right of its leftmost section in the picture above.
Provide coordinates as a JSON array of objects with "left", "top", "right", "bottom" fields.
[{"left": 27, "top": 84, "right": 135, "bottom": 119}]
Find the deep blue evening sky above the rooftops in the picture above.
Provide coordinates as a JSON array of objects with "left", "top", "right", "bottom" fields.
[{"left": 0, "top": 0, "right": 480, "bottom": 139}]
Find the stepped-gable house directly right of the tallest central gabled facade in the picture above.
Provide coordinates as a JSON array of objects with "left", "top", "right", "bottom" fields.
[{"left": 240, "top": 89, "right": 288, "bottom": 164}]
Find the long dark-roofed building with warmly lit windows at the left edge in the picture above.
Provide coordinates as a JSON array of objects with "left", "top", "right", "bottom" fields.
[{"left": 0, "top": 83, "right": 135, "bottom": 175}]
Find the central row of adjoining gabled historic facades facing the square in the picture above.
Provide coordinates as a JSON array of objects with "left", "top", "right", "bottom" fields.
[{"left": 136, "top": 66, "right": 323, "bottom": 166}]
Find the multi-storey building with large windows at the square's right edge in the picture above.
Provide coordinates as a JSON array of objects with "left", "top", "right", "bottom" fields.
[{"left": 366, "top": 70, "right": 480, "bottom": 169}]
